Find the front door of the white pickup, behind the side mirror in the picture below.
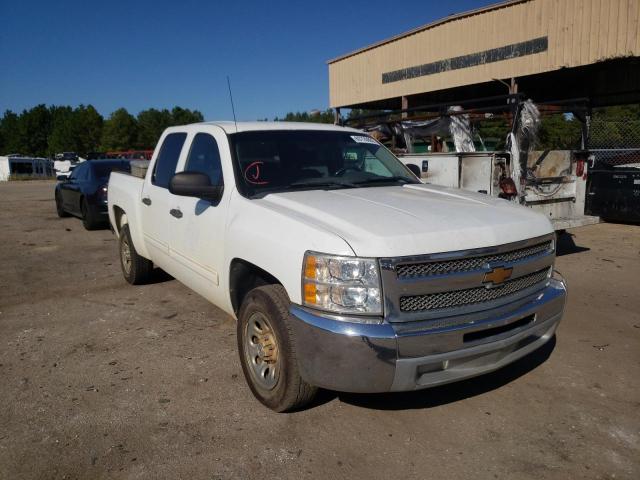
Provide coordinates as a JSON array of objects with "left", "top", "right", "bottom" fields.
[{"left": 169, "top": 129, "right": 233, "bottom": 303}]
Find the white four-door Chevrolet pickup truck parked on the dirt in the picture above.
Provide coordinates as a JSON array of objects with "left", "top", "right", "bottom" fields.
[{"left": 108, "top": 122, "right": 566, "bottom": 411}]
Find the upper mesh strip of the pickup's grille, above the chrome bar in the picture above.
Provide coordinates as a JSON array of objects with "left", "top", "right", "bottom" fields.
[{"left": 396, "top": 240, "right": 553, "bottom": 279}]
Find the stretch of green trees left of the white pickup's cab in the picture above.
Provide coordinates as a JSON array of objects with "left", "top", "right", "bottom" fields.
[{"left": 0, "top": 105, "right": 203, "bottom": 157}]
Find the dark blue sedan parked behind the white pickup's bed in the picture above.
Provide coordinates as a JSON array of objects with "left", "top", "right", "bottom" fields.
[{"left": 55, "top": 160, "right": 131, "bottom": 230}]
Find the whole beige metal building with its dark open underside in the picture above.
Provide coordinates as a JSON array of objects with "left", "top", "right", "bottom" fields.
[{"left": 328, "top": 0, "right": 640, "bottom": 109}]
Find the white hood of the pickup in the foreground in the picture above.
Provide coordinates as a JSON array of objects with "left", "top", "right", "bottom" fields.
[{"left": 256, "top": 185, "right": 553, "bottom": 257}]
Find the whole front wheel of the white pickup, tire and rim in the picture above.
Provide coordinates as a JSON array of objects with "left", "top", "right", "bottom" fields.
[{"left": 237, "top": 285, "right": 318, "bottom": 412}]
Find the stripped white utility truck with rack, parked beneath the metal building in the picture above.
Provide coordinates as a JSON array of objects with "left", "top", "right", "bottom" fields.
[{"left": 344, "top": 95, "right": 600, "bottom": 231}]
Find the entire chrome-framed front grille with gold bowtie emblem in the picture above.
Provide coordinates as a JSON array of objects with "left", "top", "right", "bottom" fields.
[{"left": 379, "top": 234, "right": 555, "bottom": 325}]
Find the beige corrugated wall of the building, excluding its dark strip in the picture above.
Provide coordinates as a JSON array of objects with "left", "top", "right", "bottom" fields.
[{"left": 329, "top": 0, "right": 640, "bottom": 108}]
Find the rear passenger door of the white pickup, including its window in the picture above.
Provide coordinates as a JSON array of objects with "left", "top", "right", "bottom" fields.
[{"left": 140, "top": 132, "right": 187, "bottom": 273}]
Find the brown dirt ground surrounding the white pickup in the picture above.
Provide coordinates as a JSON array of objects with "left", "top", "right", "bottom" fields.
[{"left": 0, "top": 182, "right": 640, "bottom": 480}]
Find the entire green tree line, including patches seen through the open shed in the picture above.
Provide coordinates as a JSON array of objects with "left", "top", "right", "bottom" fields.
[{"left": 0, "top": 105, "right": 640, "bottom": 157}]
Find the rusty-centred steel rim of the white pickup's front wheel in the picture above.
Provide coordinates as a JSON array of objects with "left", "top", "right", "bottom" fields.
[{"left": 244, "top": 312, "right": 280, "bottom": 390}]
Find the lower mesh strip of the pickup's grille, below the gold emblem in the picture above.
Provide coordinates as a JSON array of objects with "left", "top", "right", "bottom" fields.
[{"left": 400, "top": 267, "right": 550, "bottom": 312}]
